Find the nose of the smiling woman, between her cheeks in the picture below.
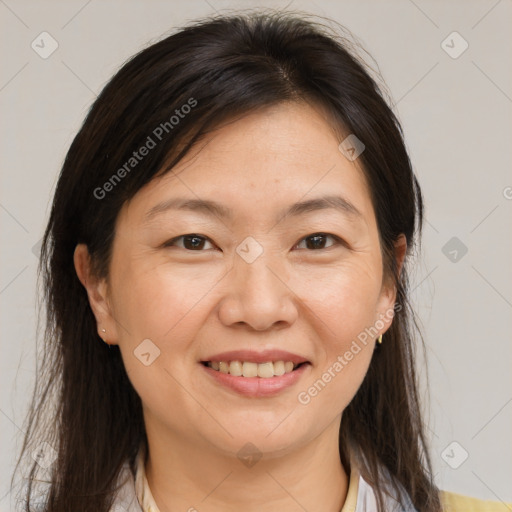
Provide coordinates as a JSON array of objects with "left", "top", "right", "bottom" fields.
[{"left": 218, "top": 253, "right": 299, "bottom": 331}]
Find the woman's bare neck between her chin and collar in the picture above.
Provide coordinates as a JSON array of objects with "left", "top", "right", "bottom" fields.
[{"left": 145, "top": 418, "right": 348, "bottom": 512}]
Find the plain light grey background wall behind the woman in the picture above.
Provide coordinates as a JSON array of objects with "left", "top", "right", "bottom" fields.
[{"left": 0, "top": 0, "right": 512, "bottom": 511}]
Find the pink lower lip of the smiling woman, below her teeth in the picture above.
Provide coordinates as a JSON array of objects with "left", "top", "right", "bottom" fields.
[{"left": 201, "top": 363, "right": 310, "bottom": 397}]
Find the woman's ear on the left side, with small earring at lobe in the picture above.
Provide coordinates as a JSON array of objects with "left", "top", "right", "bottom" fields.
[{"left": 73, "top": 244, "right": 118, "bottom": 345}]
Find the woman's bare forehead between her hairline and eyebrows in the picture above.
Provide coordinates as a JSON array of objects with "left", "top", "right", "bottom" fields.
[{"left": 122, "top": 103, "right": 372, "bottom": 225}]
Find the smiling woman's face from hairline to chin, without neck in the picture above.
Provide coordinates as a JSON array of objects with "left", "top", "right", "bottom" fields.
[{"left": 76, "top": 100, "right": 404, "bottom": 455}]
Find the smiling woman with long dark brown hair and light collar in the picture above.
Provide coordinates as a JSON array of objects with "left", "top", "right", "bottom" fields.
[{"left": 12, "top": 9, "right": 508, "bottom": 512}]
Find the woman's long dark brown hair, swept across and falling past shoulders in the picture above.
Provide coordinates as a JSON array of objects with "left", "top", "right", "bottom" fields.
[{"left": 11, "top": 11, "right": 440, "bottom": 512}]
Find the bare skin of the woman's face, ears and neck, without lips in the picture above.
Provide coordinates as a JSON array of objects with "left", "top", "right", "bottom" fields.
[{"left": 74, "top": 103, "right": 406, "bottom": 512}]
